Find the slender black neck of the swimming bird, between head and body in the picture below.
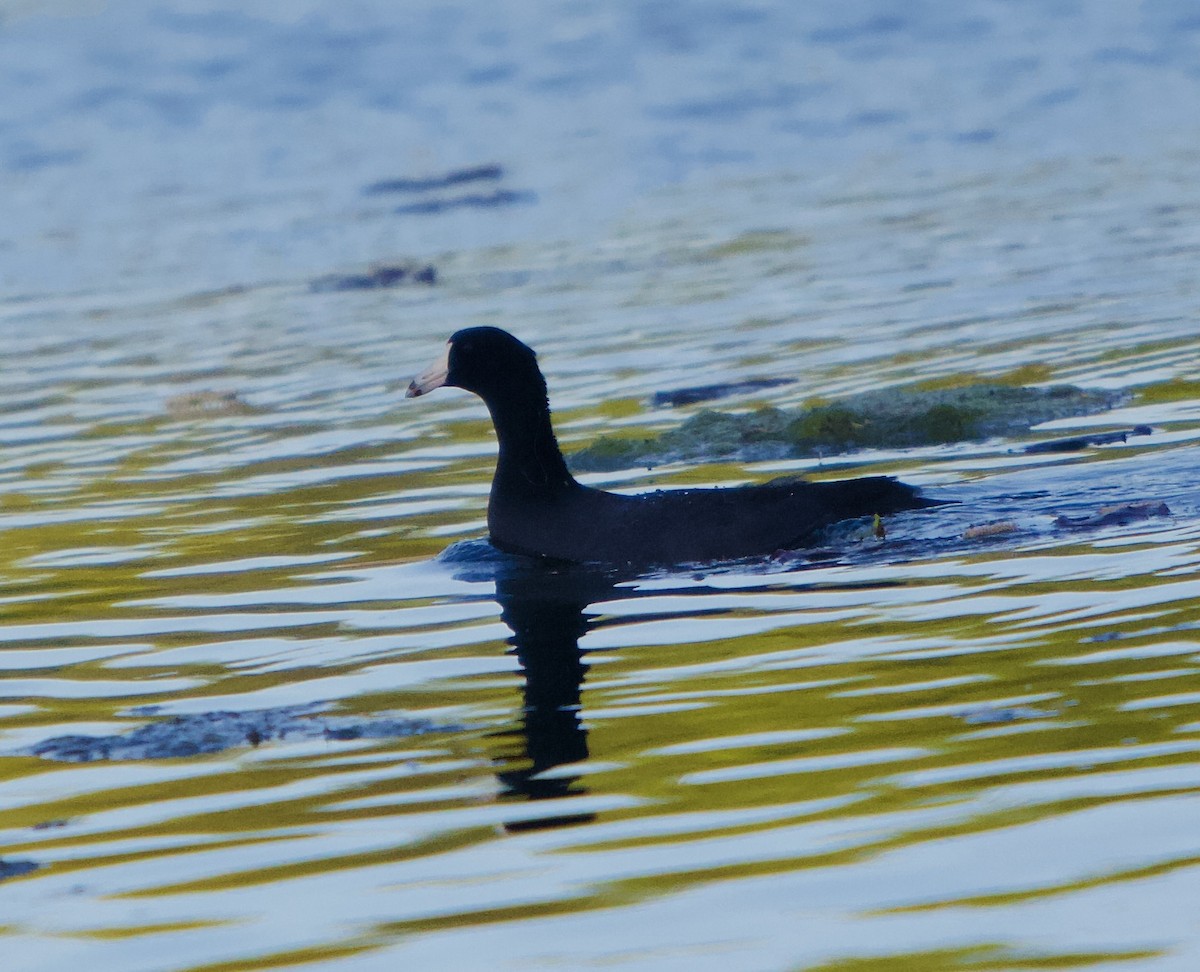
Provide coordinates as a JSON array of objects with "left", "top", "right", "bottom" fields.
[{"left": 487, "top": 389, "right": 576, "bottom": 496}]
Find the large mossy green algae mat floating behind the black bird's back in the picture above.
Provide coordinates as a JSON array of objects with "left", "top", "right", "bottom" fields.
[{"left": 568, "top": 382, "right": 1122, "bottom": 472}]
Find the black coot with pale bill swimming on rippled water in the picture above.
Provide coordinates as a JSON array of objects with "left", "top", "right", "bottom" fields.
[{"left": 407, "top": 328, "right": 937, "bottom": 565}]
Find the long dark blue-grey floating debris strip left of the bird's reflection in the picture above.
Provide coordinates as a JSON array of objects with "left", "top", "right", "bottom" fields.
[{"left": 22, "top": 704, "right": 458, "bottom": 763}]
